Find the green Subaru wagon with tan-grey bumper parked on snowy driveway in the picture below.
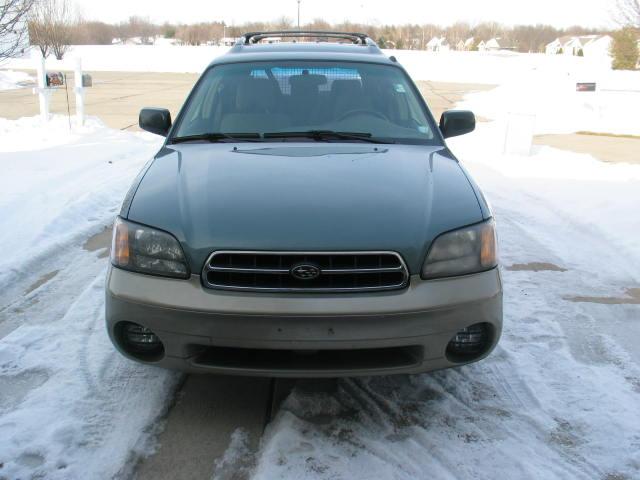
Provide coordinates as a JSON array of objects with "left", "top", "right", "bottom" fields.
[{"left": 106, "top": 32, "right": 502, "bottom": 378}]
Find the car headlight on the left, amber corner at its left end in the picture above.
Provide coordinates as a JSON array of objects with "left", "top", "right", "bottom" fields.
[{"left": 111, "top": 217, "right": 189, "bottom": 278}]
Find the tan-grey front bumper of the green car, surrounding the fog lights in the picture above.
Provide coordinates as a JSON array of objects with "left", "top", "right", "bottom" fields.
[{"left": 106, "top": 267, "right": 502, "bottom": 377}]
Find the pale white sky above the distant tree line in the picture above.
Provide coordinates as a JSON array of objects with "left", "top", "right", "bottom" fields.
[{"left": 75, "top": 0, "right": 615, "bottom": 27}]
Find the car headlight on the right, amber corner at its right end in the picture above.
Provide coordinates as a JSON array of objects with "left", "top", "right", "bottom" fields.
[{"left": 422, "top": 220, "right": 498, "bottom": 279}]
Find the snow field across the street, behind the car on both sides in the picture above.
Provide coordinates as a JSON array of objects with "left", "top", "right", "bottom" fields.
[{"left": 7, "top": 43, "right": 640, "bottom": 135}]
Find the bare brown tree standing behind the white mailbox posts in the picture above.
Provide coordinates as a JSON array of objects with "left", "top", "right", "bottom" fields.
[{"left": 29, "top": 0, "right": 76, "bottom": 60}]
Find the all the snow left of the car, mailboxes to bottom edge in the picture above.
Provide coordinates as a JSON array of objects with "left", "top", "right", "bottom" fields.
[{"left": 0, "top": 117, "right": 177, "bottom": 480}]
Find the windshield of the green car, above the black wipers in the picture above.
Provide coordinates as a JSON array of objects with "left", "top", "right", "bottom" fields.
[{"left": 174, "top": 61, "right": 439, "bottom": 144}]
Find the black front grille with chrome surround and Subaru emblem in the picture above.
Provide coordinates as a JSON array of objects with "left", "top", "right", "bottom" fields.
[{"left": 202, "top": 251, "right": 409, "bottom": 292}]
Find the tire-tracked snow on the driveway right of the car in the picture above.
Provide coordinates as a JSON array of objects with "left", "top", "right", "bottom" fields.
[{"left": 250, "top": 167, "right": 640, "bottom": 480}]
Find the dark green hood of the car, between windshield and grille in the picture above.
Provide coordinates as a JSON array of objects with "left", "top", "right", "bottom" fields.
[{"left": 123, "top": 143, "right": 483, "bottom": 273}]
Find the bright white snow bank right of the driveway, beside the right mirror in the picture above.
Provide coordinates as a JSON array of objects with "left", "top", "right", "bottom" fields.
[{"left": 448, "top": 122, "right": 640, "bottom": 276}]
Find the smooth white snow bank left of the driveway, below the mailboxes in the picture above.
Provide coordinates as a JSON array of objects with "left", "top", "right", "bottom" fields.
[{"left": 0, "top": 116, "right": 160, "bottom": 285}]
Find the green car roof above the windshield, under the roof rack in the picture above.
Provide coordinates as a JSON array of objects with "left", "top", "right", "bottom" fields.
[{"left": 209, "top": 42, "right": 397, "bottom": 66}]
